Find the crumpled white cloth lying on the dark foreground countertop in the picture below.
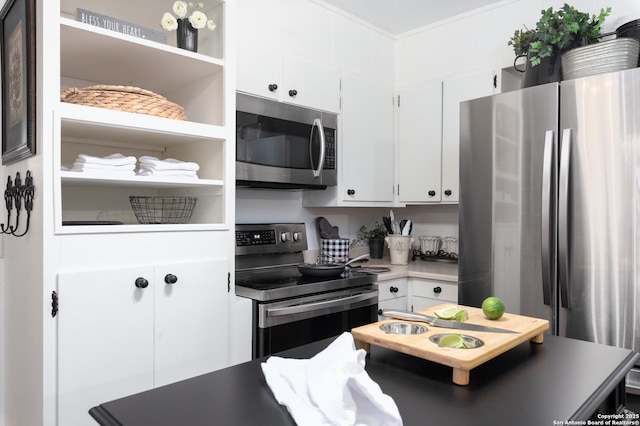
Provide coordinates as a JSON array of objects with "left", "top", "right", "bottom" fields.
[{"left": 262, "top": 332, "right": 402, "bottom": 426}]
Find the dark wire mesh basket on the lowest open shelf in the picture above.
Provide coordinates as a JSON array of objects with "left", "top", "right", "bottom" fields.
[{"left": 129, "top": 195, "right": 198, "bottom": 224}]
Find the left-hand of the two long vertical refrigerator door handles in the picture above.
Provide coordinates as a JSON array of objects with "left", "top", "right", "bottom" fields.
[{"left": 542, "top": 130, "right": 555, "bottom": 306}]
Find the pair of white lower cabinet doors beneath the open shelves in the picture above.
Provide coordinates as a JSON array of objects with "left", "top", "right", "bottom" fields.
[{"left": 57, "top": 259, "right": 230, "bottom": 426}]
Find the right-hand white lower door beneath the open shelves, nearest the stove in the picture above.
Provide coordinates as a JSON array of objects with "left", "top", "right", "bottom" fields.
[{"left": 155, "top": 260, "right": 229, "bottom": 386}]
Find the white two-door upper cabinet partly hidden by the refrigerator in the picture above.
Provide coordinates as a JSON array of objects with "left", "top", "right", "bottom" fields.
[{"left": 396, "top": 70, "right": 494, "bottom": 204}]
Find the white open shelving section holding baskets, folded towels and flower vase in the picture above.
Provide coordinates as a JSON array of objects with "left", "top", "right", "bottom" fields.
[{"left": 56, "top": 0, "right": 233, "bottom": 233}]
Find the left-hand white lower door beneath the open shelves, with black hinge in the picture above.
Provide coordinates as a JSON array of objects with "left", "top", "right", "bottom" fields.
[{"left": 57, "top": 267, "right": 154, "bottom": 426}]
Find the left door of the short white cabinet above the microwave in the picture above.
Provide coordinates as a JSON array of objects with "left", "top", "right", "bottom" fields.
[{"left": 236, "top": 45, "right": 282, "bottom": 100}]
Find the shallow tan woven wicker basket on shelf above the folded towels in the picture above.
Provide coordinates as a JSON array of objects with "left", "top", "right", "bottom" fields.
[{"left": 60, "top": 85, "right": 187, "bottom": 120}]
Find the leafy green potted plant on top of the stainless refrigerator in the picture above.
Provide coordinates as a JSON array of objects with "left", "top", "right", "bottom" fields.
[{"left": 507, "top": 3, "right": 611, "bottom": 87}]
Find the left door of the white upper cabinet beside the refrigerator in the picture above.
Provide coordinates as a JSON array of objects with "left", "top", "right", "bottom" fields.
[{"left": 396, "top": 81, "right": 442, "bottom": 203}]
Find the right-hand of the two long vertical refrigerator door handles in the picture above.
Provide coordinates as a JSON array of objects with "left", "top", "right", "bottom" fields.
[{"left": 558, "top": 129, "right": 572, "bottom": 309}]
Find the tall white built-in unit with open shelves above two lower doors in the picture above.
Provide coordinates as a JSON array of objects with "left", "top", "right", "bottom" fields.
[{"left": 2, "top": 0, "right": 238, "bottom": 426}]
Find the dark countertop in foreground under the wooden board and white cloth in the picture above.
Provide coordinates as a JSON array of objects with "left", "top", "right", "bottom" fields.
[{"left": 90, "top": 335, "right": 640, "bottom": 426}]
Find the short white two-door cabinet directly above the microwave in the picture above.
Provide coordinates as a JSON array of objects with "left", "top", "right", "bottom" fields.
[{"left": 237, "top": 45, "right": 340, "bottom": 112}]
